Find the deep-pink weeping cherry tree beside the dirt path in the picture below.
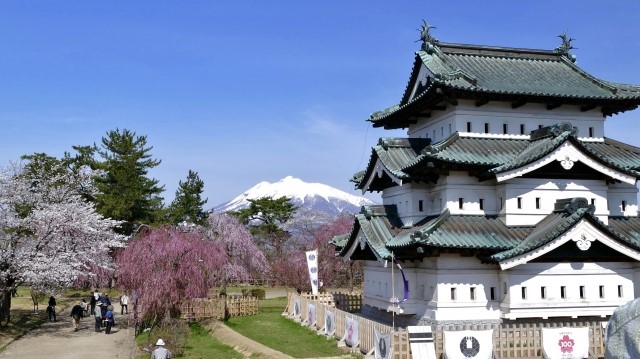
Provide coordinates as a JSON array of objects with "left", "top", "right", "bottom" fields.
[{"left": 116, "top": 227, "right": 227, "bottom": 321}]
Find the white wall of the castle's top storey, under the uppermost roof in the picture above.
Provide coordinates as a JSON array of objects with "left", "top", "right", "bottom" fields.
[{"left": 407, "top": 101, "right": 605, "bottom": 142}]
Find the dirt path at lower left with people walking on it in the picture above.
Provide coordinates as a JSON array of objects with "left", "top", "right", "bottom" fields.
[{"left": 0, "top": 303, "right": 135, "bottom": 359}]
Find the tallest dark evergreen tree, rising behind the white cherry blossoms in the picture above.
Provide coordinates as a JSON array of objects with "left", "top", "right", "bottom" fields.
[{"left": 92, "top": 129, "right": 164, "bottom": 235}]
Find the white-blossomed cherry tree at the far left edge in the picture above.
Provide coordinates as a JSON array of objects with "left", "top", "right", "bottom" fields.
[{"left": 0, "top": 162, "right": 125, "bottom": 322}]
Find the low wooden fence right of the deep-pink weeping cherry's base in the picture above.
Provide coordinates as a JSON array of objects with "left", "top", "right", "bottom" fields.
[{"left": 180, "top": 296, "right": 258, "bottom": 321}]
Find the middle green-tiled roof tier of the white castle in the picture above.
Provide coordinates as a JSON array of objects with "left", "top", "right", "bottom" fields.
[{"left": 352, "top": 123, "right": 640, "bottom": 190}]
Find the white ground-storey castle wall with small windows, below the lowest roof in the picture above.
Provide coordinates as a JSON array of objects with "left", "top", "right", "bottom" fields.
[{"left": 363, "top": 254, "right": 640, "bottom": 321}]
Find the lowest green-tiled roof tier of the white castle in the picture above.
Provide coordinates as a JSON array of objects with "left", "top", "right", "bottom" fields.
[{"left": 339, "top": 198, "right": 640, "bottom": 266}]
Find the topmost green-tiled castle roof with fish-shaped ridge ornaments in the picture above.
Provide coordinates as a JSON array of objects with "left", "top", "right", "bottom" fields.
[{"left": 369, "top": 43, "right": 640, "bottom": 128}]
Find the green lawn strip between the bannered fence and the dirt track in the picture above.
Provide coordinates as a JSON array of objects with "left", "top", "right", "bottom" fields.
[{"left": 227, "top": 297, "right": 356, "bottom": 358}]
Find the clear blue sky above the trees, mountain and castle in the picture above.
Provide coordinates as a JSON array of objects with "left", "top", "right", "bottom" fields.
[{"left": 0, "top": 0, "right": 640, "bottom": 206}]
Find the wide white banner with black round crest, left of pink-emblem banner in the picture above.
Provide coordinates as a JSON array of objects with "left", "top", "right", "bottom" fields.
[{"left": 444, "top": 329, "right": 493, "bottom": 359}]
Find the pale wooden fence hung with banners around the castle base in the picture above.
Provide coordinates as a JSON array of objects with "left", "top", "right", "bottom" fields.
[{"left": 288, "top": 293, "right": 605, "bottom": 359}]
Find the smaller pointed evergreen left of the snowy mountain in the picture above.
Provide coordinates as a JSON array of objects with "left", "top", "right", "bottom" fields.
[{"left": 169, "top": 170, "right": 207, "bottom": 225}]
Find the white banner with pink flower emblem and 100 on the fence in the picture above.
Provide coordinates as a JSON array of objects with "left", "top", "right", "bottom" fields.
[{"left": 542, "top": 327, "right": 589, "bottom": 359}]
